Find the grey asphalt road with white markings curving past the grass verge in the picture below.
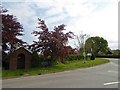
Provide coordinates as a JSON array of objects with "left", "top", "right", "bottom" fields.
[{"left": 2, "top": 59, "right": 119, "bottom": 88}]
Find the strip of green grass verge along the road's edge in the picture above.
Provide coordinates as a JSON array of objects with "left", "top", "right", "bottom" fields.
[{"left": 2, "top": 58, "right": 109, "bottom": 79}]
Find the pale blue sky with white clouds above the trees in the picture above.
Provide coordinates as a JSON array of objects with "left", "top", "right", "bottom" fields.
[{"left": 2, "top": 0, "right": 119, "bottom": 49}]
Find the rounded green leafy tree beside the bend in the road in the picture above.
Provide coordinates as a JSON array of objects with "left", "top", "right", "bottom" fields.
[{"left": 85, "top": 36, "right": 108, "bottom": 55}]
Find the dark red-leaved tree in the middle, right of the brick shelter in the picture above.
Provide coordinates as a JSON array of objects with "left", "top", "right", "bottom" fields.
[{"left": 31, "top": 19, "right": 74, "bottom": 63}]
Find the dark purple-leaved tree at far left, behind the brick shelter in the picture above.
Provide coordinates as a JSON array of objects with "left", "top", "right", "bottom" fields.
[{"left": 0, "top": 9, "right": 25, "bottom": 52}]
